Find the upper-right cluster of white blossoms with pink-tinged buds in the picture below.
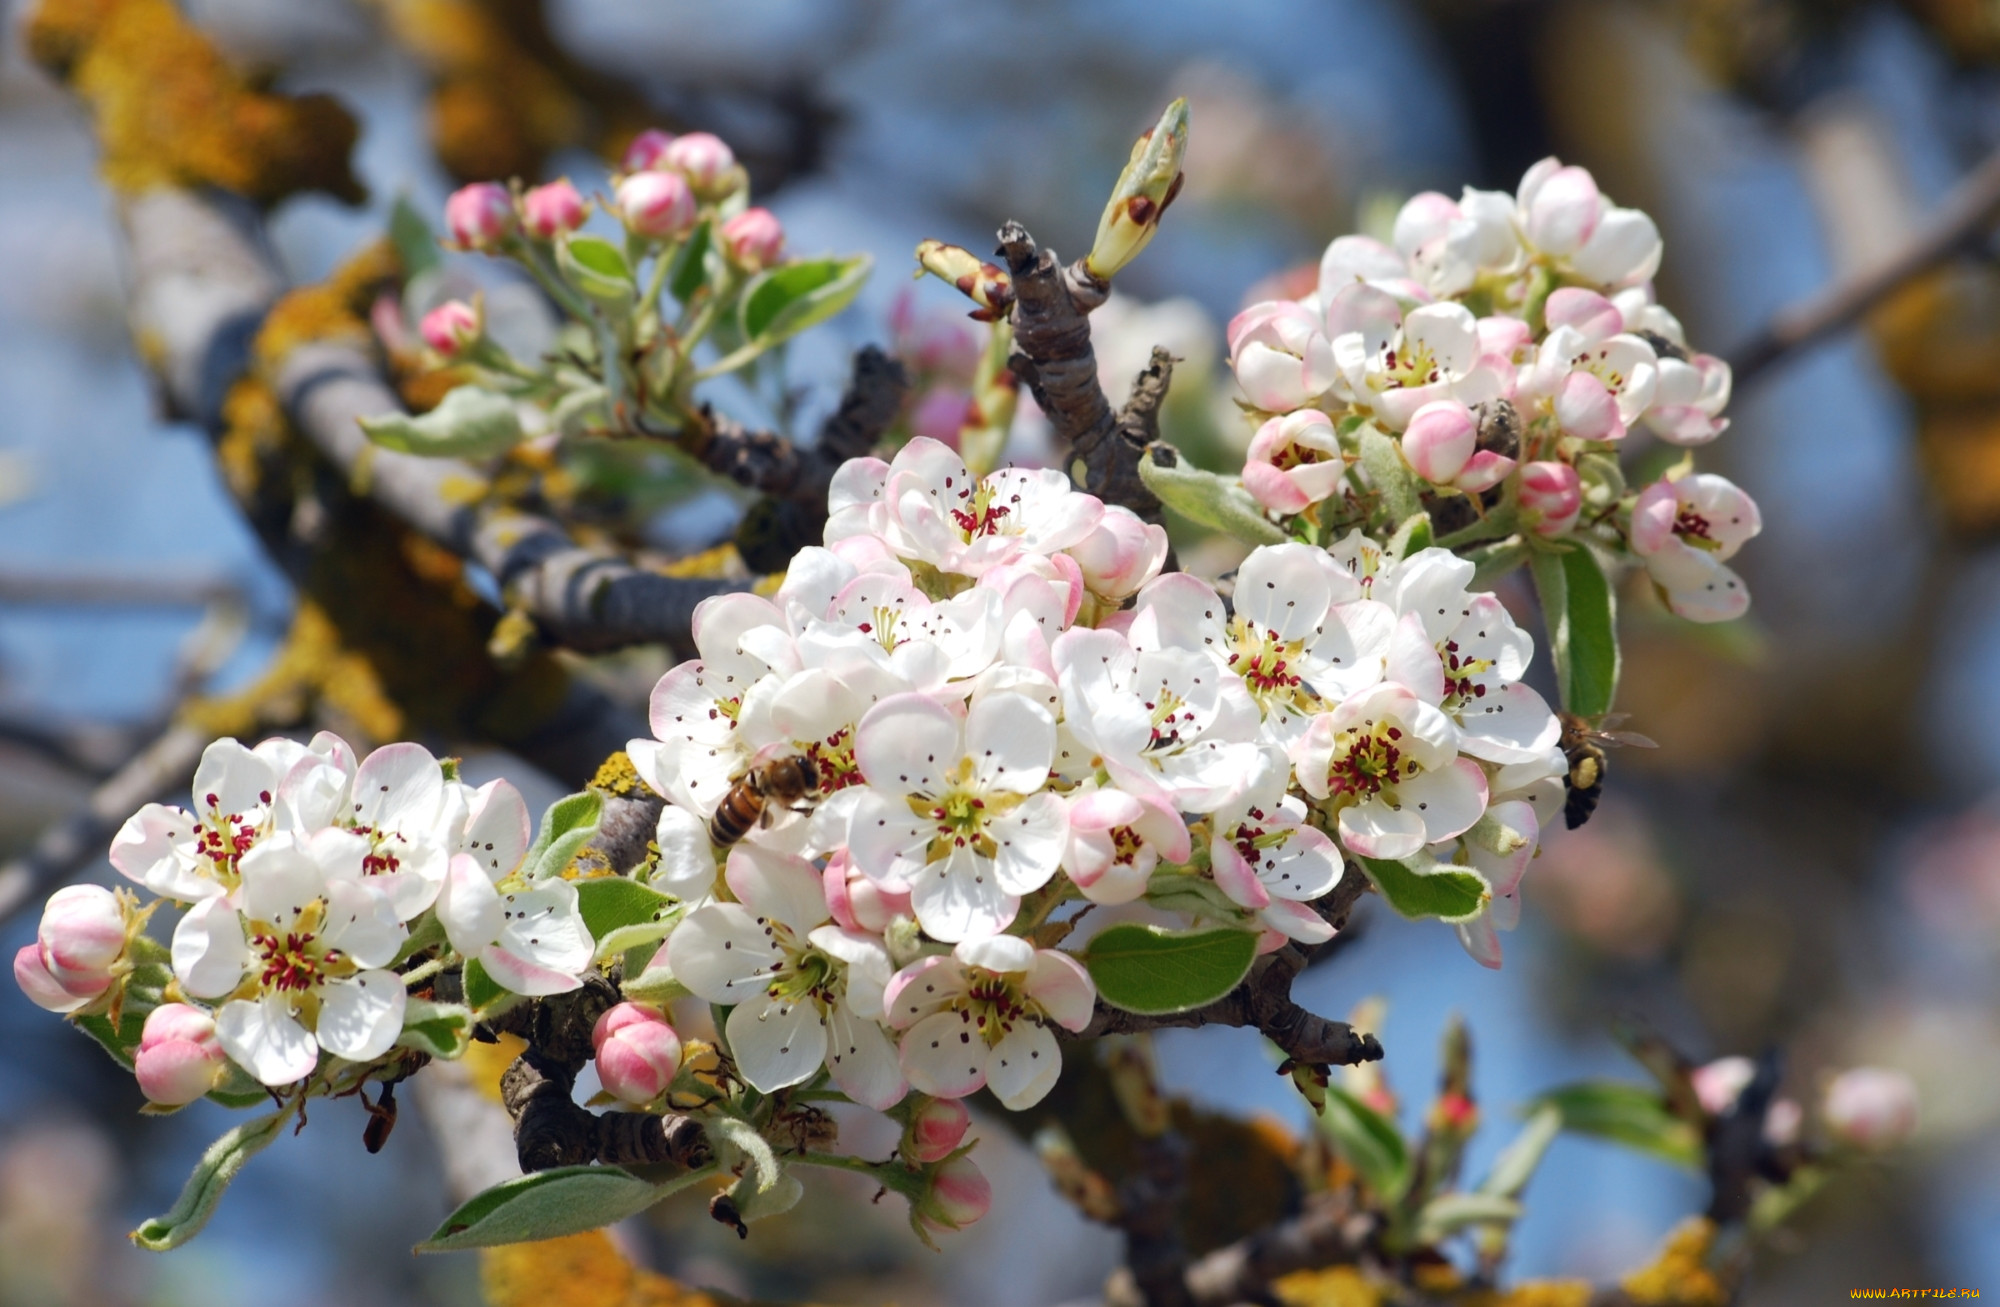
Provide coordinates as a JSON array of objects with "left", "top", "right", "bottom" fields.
[{"left": 1228, "top": 158, "right": 1760, "bottom": 622}]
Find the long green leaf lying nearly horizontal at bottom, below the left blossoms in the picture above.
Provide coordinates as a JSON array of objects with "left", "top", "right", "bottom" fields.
[{"left": 416, "top": 1165, "right": 714, "bottom": 1253}]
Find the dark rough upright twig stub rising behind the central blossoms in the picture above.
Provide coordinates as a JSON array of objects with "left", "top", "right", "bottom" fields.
[{"left": 1000, "top": 222, "right": 1172, "bottom": 522}]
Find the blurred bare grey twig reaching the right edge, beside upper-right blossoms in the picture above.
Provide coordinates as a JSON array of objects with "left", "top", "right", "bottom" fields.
[{"left": 1730, "top": 152, "right": 2000, "bottom": 386}]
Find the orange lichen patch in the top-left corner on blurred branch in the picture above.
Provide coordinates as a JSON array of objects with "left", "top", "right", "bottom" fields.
[{"left": 28, "top": 0, "right": 368, "bottom": 204}]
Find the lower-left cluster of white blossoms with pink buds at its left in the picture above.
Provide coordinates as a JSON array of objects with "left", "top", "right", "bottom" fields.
[{"left": 14, "top": 733, "right": 592, "bottom": 1103}]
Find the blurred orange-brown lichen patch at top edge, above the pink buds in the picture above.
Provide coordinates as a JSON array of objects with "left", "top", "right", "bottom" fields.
[{"left": 354, "top": 0, "right": 648, "bottom": 182}]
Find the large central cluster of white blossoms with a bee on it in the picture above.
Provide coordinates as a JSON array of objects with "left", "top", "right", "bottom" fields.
[{"left": 628, "top": 438, "right": 1566, "bottom": 1107}]
